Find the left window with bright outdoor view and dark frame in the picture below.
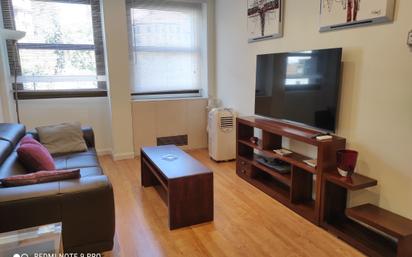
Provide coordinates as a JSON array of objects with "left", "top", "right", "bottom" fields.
[{"left": 2, "top": 0, "right": 106, "bottom": 98}]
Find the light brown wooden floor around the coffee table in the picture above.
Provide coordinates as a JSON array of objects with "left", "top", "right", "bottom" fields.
[{"left": 100, "top": 150, "right": 363, "bottom": 257}]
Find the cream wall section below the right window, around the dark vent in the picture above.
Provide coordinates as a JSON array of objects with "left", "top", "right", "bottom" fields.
[{"left": 132, "top": 98, "right": 207, "bottom": 155}]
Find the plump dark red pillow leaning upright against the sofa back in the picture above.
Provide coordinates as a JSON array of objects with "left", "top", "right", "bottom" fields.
[{"left": 17, "top": 136, "right": 56, "bottom": 172}]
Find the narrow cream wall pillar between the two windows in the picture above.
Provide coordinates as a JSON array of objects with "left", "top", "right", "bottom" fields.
[{"left": 100, "top": 0, "right": 134, "bottom": 160}]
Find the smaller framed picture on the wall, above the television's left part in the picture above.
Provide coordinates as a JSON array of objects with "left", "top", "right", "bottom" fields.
[{"left": 247, "top": 0, "right": 283, "bottom": 42}]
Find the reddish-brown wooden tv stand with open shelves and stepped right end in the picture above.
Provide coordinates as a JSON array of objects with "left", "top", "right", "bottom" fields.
[{"left": 236, "top": 117, "right": 412, "bottom": 257}]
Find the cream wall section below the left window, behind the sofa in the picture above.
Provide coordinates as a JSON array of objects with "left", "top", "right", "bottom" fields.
[{"left": 20, "top": 97, "right": 112, "bottom": 154}]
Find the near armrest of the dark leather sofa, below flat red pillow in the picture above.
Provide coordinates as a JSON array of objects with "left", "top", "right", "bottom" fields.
[{"left": 0, "top": 175, "right": 114, "bottom": 241}]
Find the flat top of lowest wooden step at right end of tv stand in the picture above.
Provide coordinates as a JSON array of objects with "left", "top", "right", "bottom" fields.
[{"left": 346, "top": 204, "right": 412, "bottom": 239}]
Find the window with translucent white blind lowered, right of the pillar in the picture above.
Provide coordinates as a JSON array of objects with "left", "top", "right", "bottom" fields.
[{"left": 127, "top": 0, "right": 205, "bottom": 96}]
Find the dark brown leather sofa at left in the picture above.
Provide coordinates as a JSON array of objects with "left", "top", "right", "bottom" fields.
[{"left": 0, "top": 123, "right": 115, "bottom": 253}]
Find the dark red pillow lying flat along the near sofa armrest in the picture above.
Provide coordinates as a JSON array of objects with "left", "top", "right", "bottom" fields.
[{"left": 0, "top": 169, "right": 80, "bottom": 187}]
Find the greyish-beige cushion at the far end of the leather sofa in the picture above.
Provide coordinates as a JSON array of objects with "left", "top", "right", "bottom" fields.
[{"left": 36, "top": 122, "right": 87, "bottom": 154}]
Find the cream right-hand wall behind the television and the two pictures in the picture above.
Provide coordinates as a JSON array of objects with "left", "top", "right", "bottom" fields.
[{"left": 216, "top": 0, "right": 412, "bottom": 218}]
